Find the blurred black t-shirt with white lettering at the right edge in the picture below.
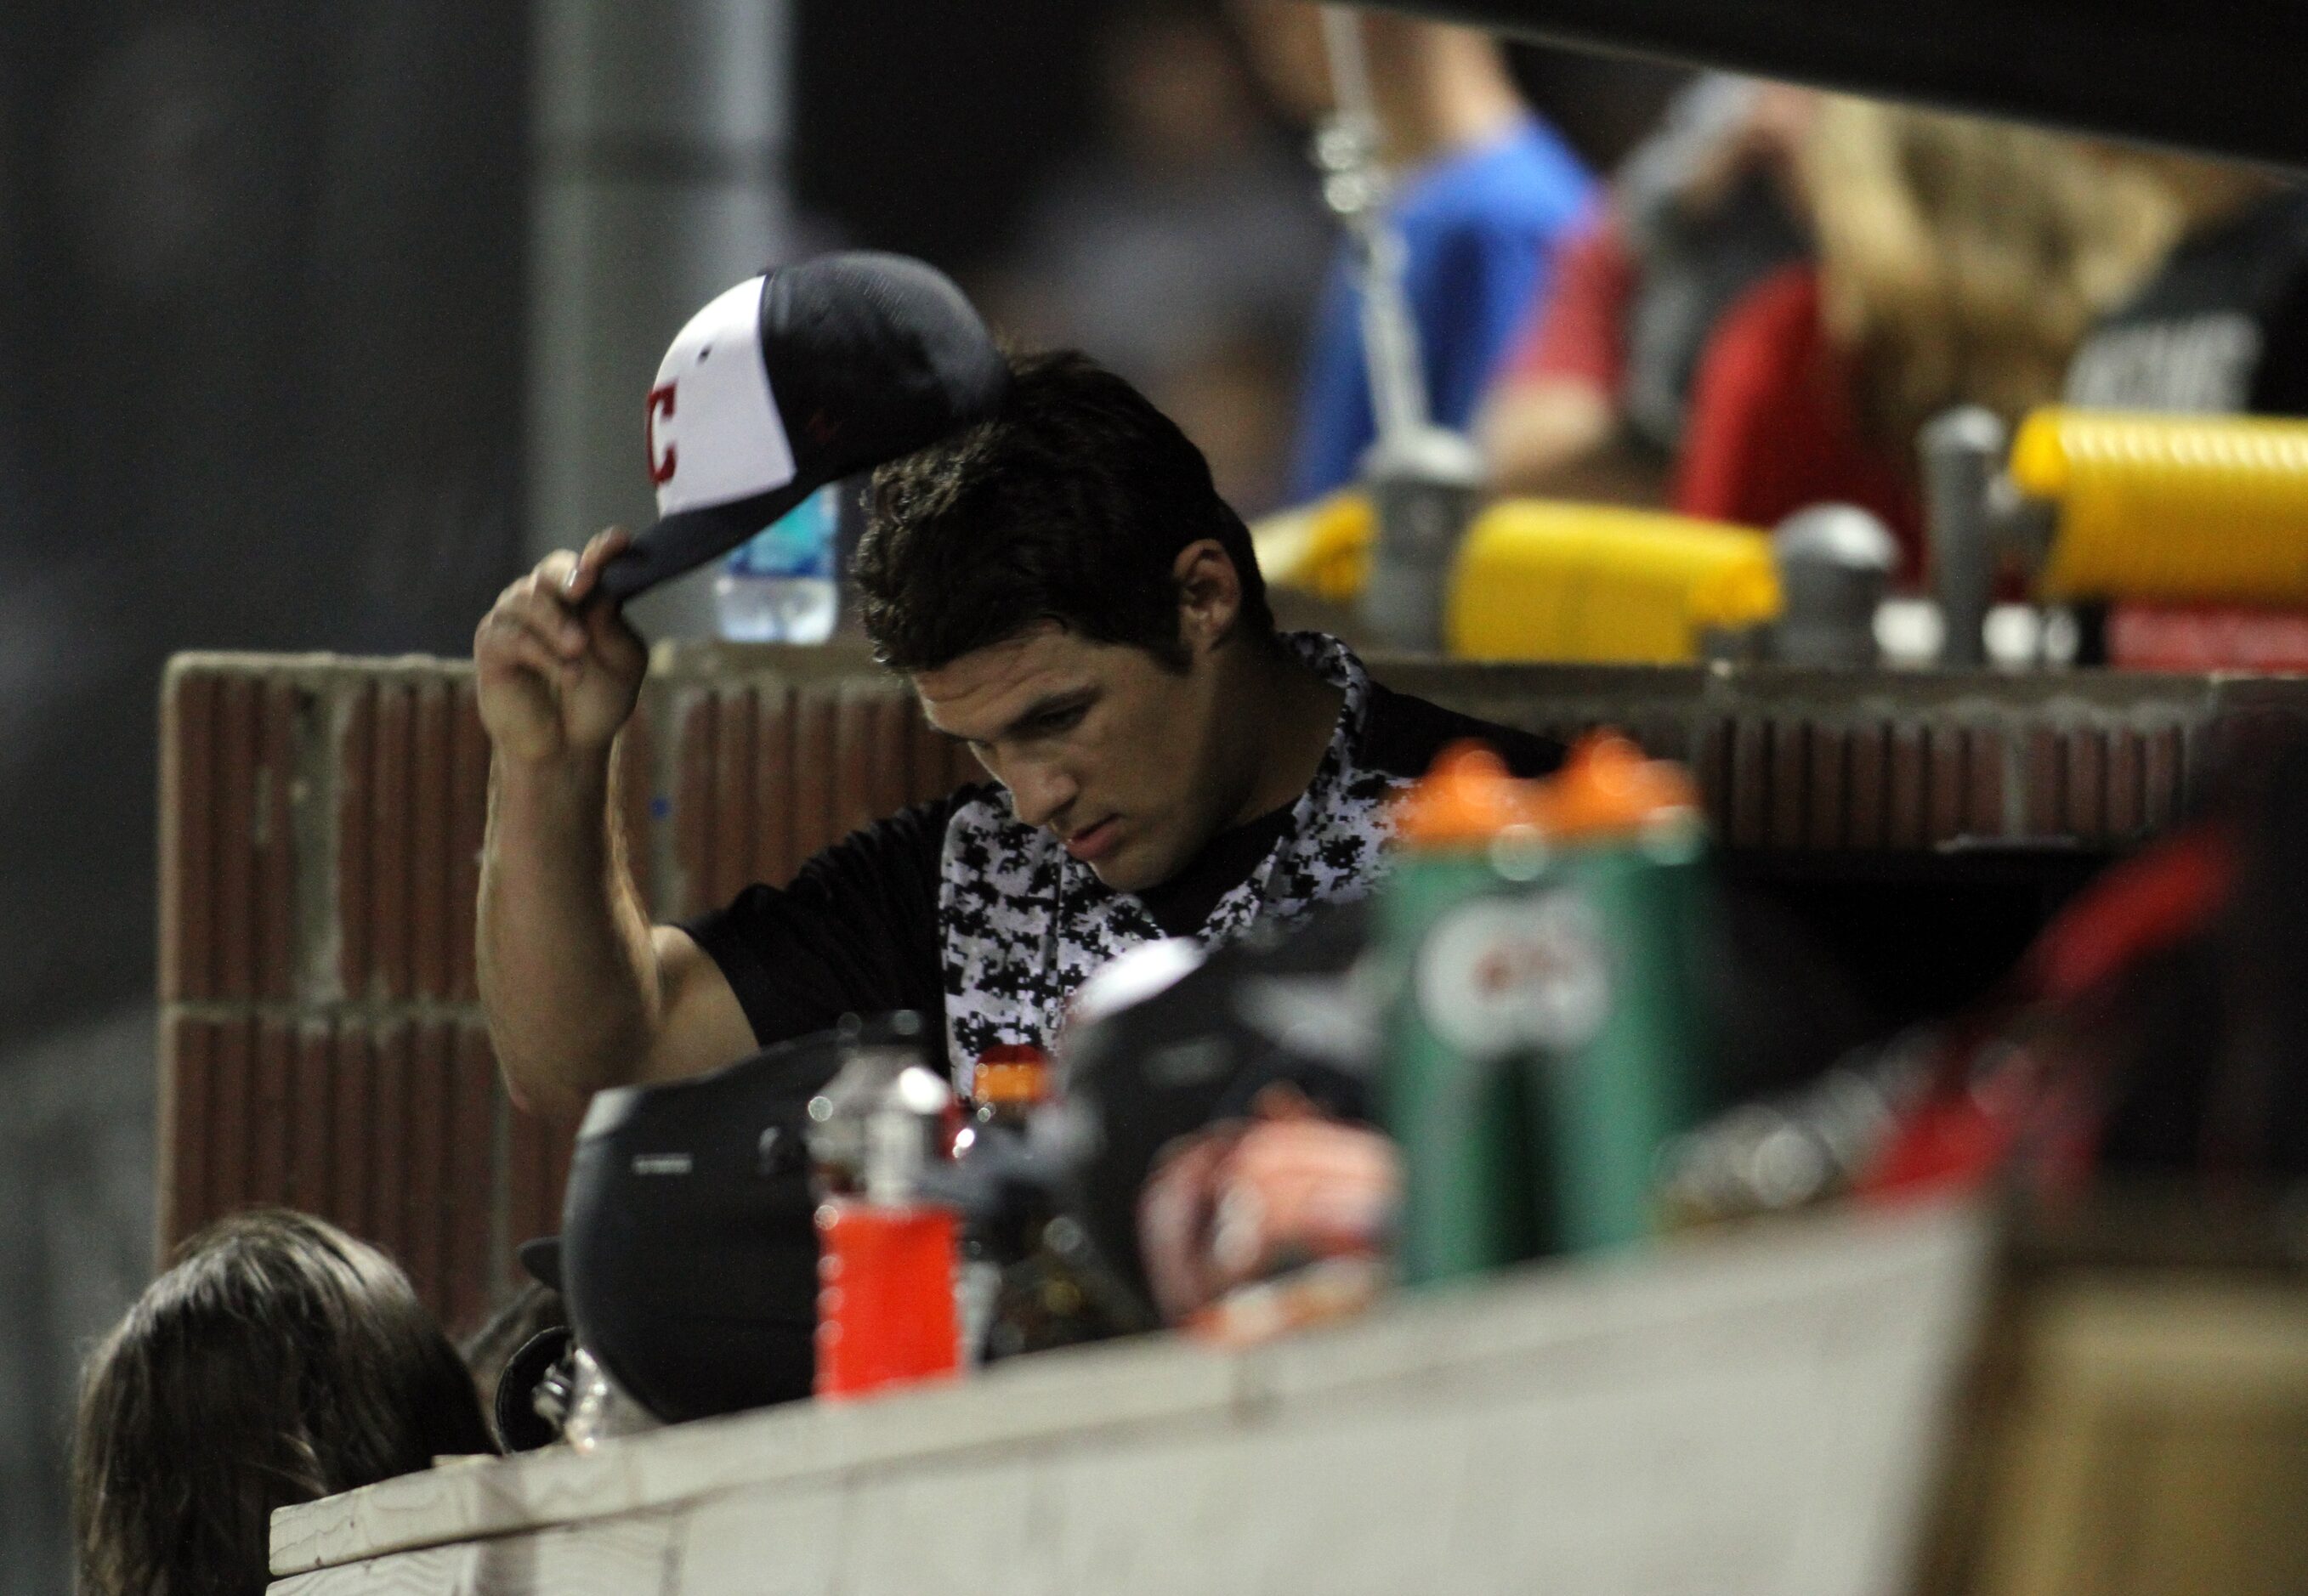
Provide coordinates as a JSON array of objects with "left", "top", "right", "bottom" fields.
[{"left": 2066, "top": 190, "right": 2308, "bottom": 415}]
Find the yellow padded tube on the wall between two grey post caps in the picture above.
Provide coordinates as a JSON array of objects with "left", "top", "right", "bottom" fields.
[{"left": 1445, "top": 498, "right": 1779, "bottom": 665}]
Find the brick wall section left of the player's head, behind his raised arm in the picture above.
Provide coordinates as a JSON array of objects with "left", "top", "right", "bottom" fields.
[{"left": 159, "top": 650, "right": 967, "bottom": 1328}]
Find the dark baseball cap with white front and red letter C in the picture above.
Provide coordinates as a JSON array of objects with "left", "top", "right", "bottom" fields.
[{"left": 600, "top": 252, "right": 1008, "bottom": 600}]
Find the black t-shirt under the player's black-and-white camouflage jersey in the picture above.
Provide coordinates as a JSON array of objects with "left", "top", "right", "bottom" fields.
[{"left": 681, "top": 682, "right": 1562, "bottom": 1047}]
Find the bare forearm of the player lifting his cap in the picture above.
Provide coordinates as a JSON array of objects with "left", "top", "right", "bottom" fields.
[{"left": 478, "top": 759, "right": 660, "bottom": 1112}]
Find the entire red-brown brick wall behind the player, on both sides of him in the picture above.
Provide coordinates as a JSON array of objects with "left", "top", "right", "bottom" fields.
[{"left": 159, "top": 646, "right": 2308, "bottom": 1328}]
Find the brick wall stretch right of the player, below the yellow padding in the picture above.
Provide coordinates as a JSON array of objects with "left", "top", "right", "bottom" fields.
[{"left": 1375, "top": 659, "right": 2308, "bottom": 853}]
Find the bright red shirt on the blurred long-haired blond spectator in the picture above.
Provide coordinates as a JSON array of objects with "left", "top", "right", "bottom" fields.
[{"left": 1673, "top": 265, "right": 1923, "bottom": 584}]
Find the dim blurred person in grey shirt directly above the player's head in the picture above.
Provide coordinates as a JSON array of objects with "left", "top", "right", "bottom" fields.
[{"left": 985, "top": 0, "right": 1332, "bottom": 514}]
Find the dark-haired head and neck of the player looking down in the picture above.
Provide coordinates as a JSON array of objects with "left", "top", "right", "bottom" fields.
[{"left": 856, "top": 351, "right": 1339, "bottom": 891}]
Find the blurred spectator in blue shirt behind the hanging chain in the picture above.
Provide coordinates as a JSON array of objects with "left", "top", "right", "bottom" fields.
[{"left": 1237, "top": 0, "right": 1595, "bottom": 501}]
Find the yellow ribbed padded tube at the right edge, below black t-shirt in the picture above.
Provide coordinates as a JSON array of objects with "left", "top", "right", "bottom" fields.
[{"left": 2010, "top": 408, "right": 2308, "bottom": 604}]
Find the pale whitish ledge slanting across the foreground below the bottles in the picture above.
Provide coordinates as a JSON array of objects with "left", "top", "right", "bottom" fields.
[{"left": 272, "top": 1208, "right": 1989, "bottom": 1596}]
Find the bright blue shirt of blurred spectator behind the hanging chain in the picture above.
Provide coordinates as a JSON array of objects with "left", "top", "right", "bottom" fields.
[{"left": 1290, "top": 117, "right": 1595, "bottom": 503}]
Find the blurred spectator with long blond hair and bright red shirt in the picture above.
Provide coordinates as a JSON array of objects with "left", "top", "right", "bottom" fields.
[{"left": 1673, "top": 97, "right": 2169, "bottom": 581}]
